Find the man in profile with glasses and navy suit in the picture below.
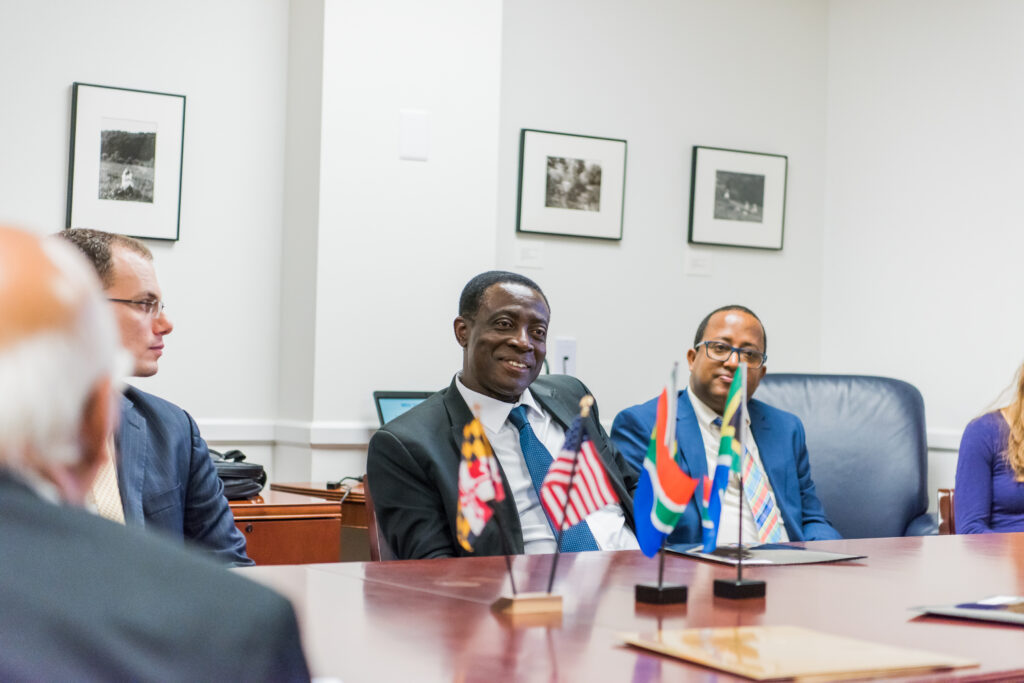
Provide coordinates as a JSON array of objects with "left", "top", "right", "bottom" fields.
[{"left": 60, "top": 228, "right": 252, "bottom": 565}]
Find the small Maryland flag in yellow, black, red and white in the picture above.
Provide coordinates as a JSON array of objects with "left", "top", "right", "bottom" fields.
[{"left": 456, "top": 418, "right": 505, "bottom": 552}]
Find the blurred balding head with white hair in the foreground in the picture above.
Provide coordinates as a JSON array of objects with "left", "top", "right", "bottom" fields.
[{"left": 0, "top": 226, "right": 120, "bottom": 503}]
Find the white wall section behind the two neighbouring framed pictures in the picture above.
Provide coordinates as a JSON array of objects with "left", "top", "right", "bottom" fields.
[{"left": 498, "top": 0, "right": 828, "bottom": 421}]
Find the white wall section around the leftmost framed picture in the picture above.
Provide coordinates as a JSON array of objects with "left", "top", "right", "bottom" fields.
[{"left": 0, "top": 0, "right": 288, "bottom": 428}]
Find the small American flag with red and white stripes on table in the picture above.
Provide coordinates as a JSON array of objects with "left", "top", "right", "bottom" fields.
[{"left": 541, "top": 417, "right": 618, "bottom": 528}]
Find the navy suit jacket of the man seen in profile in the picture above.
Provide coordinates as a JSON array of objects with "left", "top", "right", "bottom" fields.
[{"left": 116, "top": 386, "right": 252, "bottom": 565}]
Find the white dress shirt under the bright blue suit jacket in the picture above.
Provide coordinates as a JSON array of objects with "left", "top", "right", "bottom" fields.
[{"left": 686, "top": 385, "right": 790, "bottom": 546}]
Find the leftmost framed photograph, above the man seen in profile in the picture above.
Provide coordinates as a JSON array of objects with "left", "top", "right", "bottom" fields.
[{"left": 66, "top": 82, "right": 185, "bottom": 241}]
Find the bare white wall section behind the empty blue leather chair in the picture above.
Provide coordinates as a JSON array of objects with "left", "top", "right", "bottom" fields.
[{"left": 821, "top": 0, "right": 1024, "bottom": 497}]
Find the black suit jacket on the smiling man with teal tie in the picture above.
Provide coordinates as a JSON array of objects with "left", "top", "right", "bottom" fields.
[{"left": 367, "top": 375, "right": 638, "bottom": 559}]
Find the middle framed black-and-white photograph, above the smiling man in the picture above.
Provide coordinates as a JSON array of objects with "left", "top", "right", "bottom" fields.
[{"left": 516, "top": 128, "right": 626, "bottom": 240}]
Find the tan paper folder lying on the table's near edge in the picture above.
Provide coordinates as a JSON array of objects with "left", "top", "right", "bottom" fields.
[{"left": 623, "top": 626, "right": 978, "bottom": 681}]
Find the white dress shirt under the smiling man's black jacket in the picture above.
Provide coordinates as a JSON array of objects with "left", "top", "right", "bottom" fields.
[{"left": 456, "top": 376, "right": 640, "bottom": 554}]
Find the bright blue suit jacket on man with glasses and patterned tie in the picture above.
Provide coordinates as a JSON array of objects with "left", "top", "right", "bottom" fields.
[{"left": 611, "top": 391, "right": 840, "bottom": 544}]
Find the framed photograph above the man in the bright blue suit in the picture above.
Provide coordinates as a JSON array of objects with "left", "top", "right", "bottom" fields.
[{"left": 687, "top": 146, "right": 788, "bottom": 251}]
